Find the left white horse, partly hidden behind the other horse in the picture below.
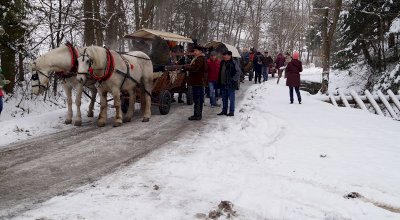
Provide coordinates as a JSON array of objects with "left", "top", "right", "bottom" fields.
[{"left": 30, "top": 43, "right": 97, "bottom": 126}]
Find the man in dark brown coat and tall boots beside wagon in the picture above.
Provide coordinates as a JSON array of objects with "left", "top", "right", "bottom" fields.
[{"left": 186, "top": 46, "right": 207, "bottom": 121}]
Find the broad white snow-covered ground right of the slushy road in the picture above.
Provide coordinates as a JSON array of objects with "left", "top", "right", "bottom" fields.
[{"left": 15, "top": 81, "right": 400, "bottom": 220}]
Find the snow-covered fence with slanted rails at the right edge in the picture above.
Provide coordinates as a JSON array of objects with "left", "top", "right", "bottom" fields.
[{"left": 317, "top": 89, "right": 400, "bottom": 120}]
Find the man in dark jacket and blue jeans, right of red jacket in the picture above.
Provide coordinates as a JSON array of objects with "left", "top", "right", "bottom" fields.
[{"left": 218, "top": 51, "right": 241, "bottom": 116}]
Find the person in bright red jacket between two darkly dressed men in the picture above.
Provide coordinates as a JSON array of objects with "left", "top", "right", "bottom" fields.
[{"left": 207, "top": 51, "right": 221, "bottom": 108}]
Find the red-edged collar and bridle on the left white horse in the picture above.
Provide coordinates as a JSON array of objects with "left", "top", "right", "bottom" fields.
[{"left": 31, "top": 42, "right": 78, "bottom": 89}]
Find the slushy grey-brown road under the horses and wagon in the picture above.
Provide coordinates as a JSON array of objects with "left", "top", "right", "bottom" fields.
[{"left": 0, "top": 86, "right": 248, "bottom": 218}]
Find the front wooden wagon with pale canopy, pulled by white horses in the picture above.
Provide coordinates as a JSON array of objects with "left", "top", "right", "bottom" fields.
[{"left": 122, "top": 29, "right": 193, "bottom": 115}]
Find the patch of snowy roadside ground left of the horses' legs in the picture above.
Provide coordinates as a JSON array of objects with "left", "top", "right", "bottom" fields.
[{"left": 0, "top": 90, "right": 98, "bottom": 148}]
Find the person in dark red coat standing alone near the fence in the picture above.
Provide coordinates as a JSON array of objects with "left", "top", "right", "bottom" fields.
[{"left": 286, "top": 51, "right": 303, "bottom": 104}]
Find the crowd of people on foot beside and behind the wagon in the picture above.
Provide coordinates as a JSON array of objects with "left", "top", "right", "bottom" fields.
[{"left": 185, "top": 46, "right": 303, "bottom": 121}]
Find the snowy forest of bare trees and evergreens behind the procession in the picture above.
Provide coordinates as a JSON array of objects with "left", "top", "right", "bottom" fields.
[{"left": 0, "top": 0, "right": 400, "bottom": 94}]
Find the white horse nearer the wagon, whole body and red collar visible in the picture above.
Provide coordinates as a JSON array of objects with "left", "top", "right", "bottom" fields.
[{"left": 77, "top": 46, "right": 153, "bottom": 127}]
